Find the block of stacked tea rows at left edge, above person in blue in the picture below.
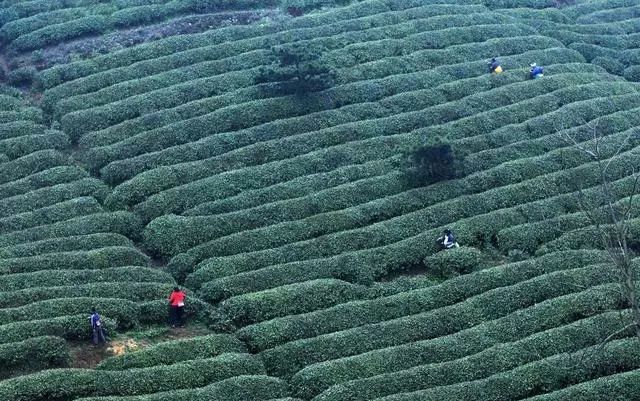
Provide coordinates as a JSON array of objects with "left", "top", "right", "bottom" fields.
[{"left": 0, "top": 85, "right": 210, "bottom": 378}]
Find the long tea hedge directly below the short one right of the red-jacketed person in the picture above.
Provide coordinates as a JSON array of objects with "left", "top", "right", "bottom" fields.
[{"left": 237, "top": 251, "right": 606, "bottom": 351}]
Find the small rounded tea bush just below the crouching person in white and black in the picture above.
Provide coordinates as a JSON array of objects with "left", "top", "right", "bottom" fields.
[{"left": 423, "top": 246, "right": 486, "bottom": 278}]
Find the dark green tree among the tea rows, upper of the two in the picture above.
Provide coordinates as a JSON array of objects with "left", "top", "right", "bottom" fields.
[{"left": 255, "top": 44, "right": 335, "bottom": 95}]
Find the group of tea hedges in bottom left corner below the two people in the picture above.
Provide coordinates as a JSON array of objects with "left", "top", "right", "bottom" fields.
[{"left": 0, "top": 335, "right": 289, "bottom": 401}]
